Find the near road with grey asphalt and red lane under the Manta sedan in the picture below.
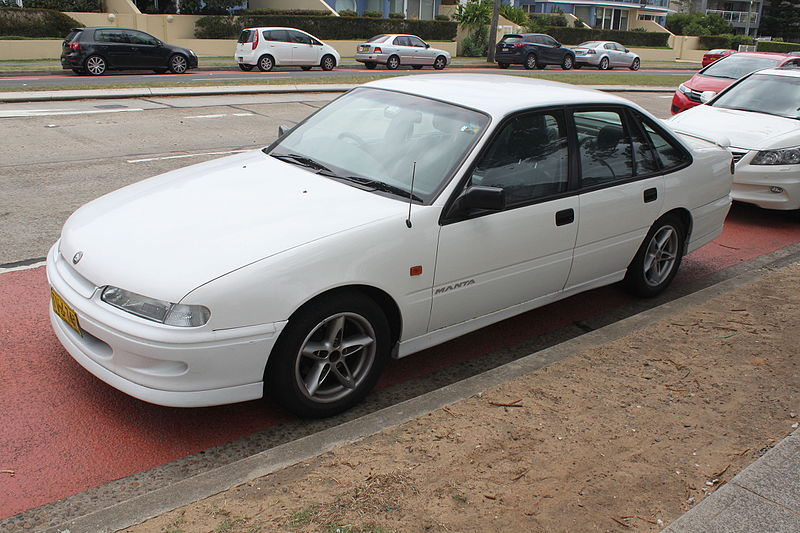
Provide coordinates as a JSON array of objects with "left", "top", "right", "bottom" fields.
[{"left": 0, "top": 88, "right": 800, "bottom": 531}]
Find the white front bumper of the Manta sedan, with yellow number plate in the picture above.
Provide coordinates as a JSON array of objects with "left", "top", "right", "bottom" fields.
[{"left": 47, "top": 243, "right": 286, "bottom": 407}]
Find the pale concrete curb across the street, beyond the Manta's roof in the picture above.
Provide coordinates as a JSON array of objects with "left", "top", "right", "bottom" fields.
[{"left": 0, "top": 84, "right": 675, "bottom": 103}]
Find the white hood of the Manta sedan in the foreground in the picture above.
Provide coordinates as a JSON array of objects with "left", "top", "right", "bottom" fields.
[{"left": 60, "top": 151, "right": 406, "bottom": 302}]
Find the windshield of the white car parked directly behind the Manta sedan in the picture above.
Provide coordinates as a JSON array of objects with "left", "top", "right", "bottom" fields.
[{"left": 711, "top": 74, "right": 800, "bottom": 119}]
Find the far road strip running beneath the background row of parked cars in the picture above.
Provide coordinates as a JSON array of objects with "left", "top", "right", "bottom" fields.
[{"left": 0, "top": 66, "right": 697, "bottom": 89}]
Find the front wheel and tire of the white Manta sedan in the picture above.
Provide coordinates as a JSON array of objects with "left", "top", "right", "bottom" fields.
[{"left": 264, "top": 292, "right": 391, "bottom": 418}]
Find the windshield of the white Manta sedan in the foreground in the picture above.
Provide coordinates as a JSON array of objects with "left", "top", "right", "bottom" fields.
[{"left": 264, "top": 88, "right": 489, "bottom": 203}]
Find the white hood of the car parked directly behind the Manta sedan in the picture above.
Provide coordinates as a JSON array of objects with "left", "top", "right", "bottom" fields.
[{"left": 668, "top": 105, "right": 800, "bottom": 150}]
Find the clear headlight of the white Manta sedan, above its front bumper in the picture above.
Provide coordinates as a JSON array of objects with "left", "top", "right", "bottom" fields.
[{"left": 100, "top": 286, "right": 211, "bottom": 327}]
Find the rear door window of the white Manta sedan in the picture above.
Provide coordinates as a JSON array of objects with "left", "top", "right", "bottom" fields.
[{"left": 573, "top": 111, "right": 634, "bottom": 187}]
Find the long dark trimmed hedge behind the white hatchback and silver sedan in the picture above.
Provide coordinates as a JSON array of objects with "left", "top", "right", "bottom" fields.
[{"left": 194, "top": 15, "right": 458, "bottom": 41}]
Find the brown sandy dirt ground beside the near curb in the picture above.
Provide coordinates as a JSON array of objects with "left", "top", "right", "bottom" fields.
[{"left": 125, "top": 264, "right": 800, "bottom": 533}]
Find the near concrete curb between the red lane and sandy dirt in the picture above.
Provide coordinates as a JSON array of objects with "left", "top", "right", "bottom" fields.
[{"left": 45, "top": 247, "right": 800, "bottom": 533}]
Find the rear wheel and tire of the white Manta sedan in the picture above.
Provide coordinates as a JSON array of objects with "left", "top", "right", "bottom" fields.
[{"left": 624, "top": 214, "right": 686, "bottom": 298}]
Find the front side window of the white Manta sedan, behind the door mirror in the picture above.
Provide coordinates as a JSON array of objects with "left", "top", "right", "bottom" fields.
[{"left": 470, "top": 112, "right": 569, "bottom": 207}]
